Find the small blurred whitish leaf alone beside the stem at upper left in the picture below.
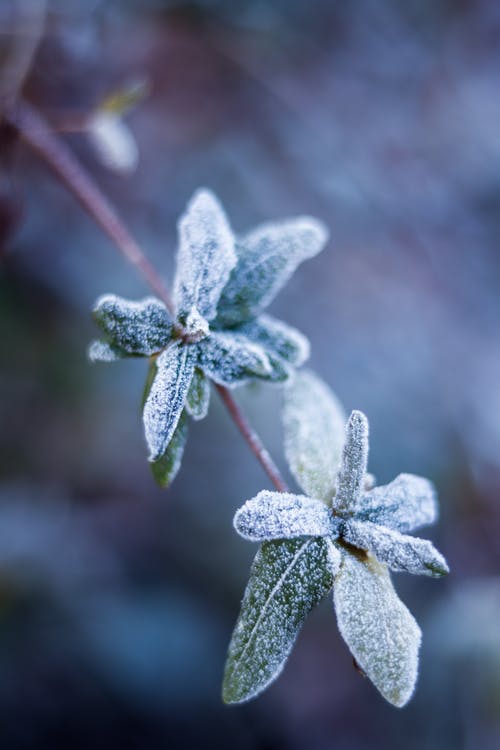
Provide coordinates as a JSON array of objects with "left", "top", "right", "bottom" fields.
[{"left": 87, "top": 110, "right": 139, "bottom": 174}]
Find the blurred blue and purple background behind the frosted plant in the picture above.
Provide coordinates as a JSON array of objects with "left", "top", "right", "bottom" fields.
[{"left": 0, "top": 0, "right": 500, "bottom": 750}]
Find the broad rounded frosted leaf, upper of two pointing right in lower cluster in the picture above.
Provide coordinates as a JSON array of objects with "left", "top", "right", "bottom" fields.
[{"left": 356, "top": 474, "right": 438, "bottom": 533}]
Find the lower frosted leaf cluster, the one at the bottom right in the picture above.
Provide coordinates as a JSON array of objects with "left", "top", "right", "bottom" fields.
[{"left": 223, "top": 372, "right": 448, "bottom": 706}]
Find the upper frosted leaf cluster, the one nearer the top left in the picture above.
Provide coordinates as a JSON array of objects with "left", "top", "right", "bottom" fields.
[{"left": 89, "top": 190, "right": 328, "bottom": 487}]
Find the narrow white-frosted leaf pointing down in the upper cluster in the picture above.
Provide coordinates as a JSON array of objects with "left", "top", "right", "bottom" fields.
[{"left": 143, "top": 342, "right": 196, "bottom": 461}]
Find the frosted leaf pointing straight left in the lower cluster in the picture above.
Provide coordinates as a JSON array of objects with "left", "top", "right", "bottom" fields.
[{"left": 234, "top": 490, "right": 334, "bottom": 542}]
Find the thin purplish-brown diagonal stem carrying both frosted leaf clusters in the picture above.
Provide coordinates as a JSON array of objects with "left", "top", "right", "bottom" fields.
[{"left": 4, "top": 101, "right": 288, "bottom": 500}]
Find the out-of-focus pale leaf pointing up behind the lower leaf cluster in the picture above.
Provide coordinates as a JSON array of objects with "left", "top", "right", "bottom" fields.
[{"left": 283, "top": 371, "right": 345, "bottom": 502}]
